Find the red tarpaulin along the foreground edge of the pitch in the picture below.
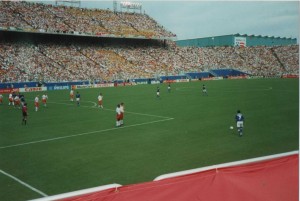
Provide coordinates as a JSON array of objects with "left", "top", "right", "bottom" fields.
[{"left": 61, "top": 154, "right": 299, "bottom": 201}]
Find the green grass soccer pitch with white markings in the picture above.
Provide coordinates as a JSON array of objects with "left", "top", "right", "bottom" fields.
[{"left": 0, "top": 79, "right": 299, "bottom": 201}]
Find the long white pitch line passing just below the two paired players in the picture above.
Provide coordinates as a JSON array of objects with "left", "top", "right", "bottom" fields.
[{"left": 0, "top": 118, "right": 174, "bottom": 149}]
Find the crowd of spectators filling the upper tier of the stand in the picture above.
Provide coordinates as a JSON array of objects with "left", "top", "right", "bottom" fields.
[{"left": 0, "top": 1, "right": 175, "bottom": 38}]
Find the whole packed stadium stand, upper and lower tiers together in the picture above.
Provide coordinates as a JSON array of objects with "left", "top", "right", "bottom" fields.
[{"left": 0, "top": 1, "right": 299, "bottom": 82}]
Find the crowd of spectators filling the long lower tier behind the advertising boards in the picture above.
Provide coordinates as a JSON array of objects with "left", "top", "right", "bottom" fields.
[{"left": 0, "top": 41, "right": 299, "bottom": 82}]
